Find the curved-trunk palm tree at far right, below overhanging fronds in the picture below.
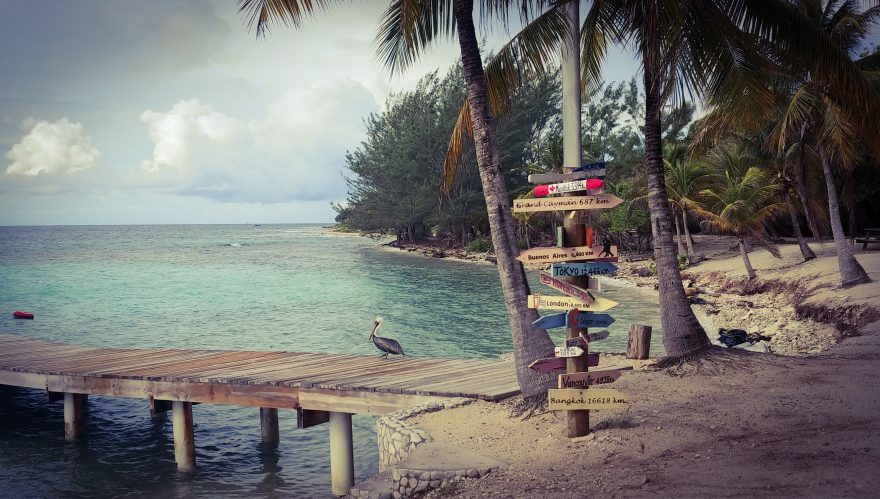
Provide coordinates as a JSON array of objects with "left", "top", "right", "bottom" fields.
[{"left": 777, "top": 0, "right": 880, "bottom": 287}]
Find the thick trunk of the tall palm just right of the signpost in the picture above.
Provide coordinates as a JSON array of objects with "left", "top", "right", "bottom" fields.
[{"left": 639, "top": 12, "right": 710, "bottom": 358}]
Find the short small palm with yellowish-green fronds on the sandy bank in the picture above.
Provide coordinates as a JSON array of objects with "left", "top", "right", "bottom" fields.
[{"left": 695, "top": 167, "right": 785, "bottom": 279}]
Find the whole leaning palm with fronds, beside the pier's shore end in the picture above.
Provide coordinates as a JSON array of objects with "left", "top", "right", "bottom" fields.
[{"left": 239, "top": 0, "right": 564, "bottom": 399}]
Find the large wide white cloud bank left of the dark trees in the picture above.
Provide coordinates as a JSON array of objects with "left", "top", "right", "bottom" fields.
[{"left": 129, "top": 80, "right": 378, "bottom": 203}]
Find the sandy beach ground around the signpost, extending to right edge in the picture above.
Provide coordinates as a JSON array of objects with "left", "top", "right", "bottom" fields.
[{"left": 384, "top": 236, "right": 880, "bottom": 497}]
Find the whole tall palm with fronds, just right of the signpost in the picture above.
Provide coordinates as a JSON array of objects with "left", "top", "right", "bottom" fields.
[{"left": 444, "top": 0, "right": 873, "bottom": 359}]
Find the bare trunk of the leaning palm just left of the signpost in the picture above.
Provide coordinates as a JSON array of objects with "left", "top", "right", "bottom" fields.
[{"left": 453, "top": 0, "right": 555, "bottom": 398}]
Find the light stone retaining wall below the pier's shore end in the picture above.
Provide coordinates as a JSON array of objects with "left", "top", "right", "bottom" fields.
[{"left": 376, "top": 399, "right": 474, "bottom": 472}]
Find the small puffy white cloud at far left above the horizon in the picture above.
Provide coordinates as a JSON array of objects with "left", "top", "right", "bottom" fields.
[{"left": 6, "top": 117, "right": 101, "bottom": 176}]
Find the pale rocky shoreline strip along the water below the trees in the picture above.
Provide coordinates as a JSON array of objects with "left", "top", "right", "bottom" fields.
[{"left": 332, "top": 227, "right": 880, "bottom": 356}]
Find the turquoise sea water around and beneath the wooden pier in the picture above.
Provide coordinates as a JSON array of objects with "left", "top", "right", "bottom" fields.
[{"left": 0, "top": 225, "right": 662, "bottom": 497}]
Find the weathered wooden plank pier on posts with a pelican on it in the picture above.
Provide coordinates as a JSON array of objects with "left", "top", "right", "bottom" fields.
[{"left": 0, "top": 333, "right": 519, "bottom": 495}]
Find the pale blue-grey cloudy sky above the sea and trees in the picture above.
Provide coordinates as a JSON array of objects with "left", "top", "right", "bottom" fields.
[{"left": 0, "top": 0, "right": 637, "bottom": 225}]
